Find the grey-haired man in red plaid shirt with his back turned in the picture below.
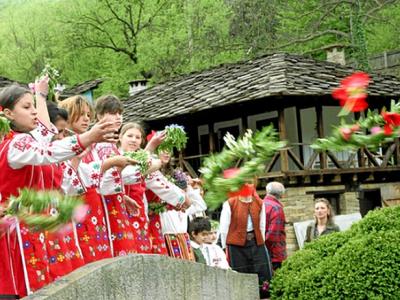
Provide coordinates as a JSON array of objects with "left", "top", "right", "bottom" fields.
[{"left": 263, "top": 181, "right": 287, "bottom": 271}]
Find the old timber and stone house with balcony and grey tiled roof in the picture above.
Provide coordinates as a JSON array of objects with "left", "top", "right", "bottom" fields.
[{"left": 125, "top": 53, "right": 400, "bottom": 250}]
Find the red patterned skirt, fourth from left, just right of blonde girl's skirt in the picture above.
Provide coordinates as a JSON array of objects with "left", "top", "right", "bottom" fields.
[{"left": 103, "top": 193, "right": 136, "bottom": 256}]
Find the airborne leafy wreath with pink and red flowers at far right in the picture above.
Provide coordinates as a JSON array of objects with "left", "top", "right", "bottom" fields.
[{"left": 311, "top": 101, "right": 400, "bottom": 151}]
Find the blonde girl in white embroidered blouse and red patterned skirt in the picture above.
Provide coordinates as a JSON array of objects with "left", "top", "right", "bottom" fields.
[{"left": 60, "top": 96, "right": 133, "bottom": 263}]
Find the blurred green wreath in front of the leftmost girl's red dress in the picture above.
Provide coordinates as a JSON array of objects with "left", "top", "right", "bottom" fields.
[{"left": 5, "top": 188, "right": 82, "bottom": 231}]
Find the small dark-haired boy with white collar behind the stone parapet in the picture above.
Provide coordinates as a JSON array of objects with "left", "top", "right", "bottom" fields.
[{"left": 189, "top": 217, "right": 211, "bottom": 264}]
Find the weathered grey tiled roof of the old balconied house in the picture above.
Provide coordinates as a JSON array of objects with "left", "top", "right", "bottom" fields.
[{"left": 125, "top": 53, "right": 400, "bottom": 121}]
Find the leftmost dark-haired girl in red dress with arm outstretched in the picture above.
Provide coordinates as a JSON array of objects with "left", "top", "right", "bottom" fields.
[{"left": 0, "top": 86, "right": 117, "bottom": 296}]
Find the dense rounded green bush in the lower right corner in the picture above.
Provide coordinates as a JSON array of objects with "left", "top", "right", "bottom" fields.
[{"left": 271, "top": 207, "right": 400, "bottom": 299}]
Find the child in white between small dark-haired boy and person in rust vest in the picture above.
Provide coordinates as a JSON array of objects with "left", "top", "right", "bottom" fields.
[{"left": 201, "top": 220, "right": 230, "bottom": 269}]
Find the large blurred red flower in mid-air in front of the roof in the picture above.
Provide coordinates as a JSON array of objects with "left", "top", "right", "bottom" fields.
[{"left": 332, "top": 72, "right": 370, "bottom": 113}]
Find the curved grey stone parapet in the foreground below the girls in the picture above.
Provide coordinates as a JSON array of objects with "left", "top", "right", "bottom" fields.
[{"left": 25, "top": 255, "right": 259, "bottom": 300}]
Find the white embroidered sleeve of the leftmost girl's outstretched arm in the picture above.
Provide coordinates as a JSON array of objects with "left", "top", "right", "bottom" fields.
[{"left": 7, "top": 133, "right": 84, "bottom": 169}]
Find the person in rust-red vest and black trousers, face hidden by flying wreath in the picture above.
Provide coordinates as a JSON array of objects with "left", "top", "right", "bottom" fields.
[{"left": 220, "top": 169, "right": 272, "bottom": 298}]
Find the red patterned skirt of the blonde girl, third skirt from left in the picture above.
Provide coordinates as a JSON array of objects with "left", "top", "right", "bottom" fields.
[{"left": 75, "top": 188, "right": 112, "bottom": 263}]
